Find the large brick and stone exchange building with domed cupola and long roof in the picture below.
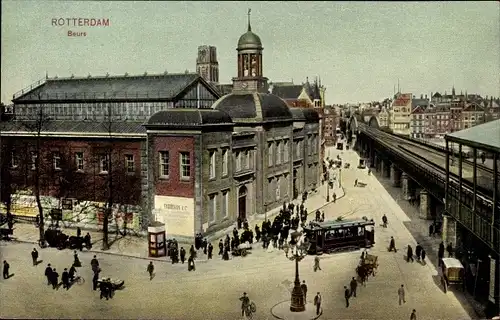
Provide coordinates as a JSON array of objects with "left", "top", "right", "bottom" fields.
[{"left": 0, "top": 16, "right": 320, "bottom": 238}]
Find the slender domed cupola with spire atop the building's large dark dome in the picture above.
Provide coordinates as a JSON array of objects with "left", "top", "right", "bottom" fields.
[{"left": 233, "top": 9, "right": 269, "bottom": 93}]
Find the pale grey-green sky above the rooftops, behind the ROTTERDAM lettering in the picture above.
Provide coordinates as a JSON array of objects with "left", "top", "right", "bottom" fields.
[{"left": 1, "top": 0, "right": 500, "bottom": 104}]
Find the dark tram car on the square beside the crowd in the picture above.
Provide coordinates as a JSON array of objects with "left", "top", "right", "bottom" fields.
[{"left": 303, "top": 219, "right": 375, "bottom": 255}]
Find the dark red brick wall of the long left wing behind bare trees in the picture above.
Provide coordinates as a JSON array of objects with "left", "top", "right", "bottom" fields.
[{"left": 2, "top": 137, "right": 141, "bottom": 204}]
